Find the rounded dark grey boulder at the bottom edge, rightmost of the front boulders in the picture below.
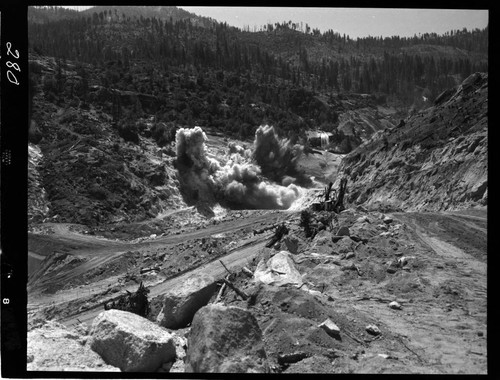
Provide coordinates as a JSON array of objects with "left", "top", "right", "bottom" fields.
[{"left": 186, "top": 304, "right": 269, "bottom": 373}]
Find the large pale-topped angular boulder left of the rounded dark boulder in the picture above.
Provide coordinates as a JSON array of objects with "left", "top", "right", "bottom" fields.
[{"left": 88, "top": 310, "right": 175, "bottom": 372}]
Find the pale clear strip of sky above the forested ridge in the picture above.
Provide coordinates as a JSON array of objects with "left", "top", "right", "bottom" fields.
[{"left": 60, "top": 6, "right": 488, "bottom": 39}]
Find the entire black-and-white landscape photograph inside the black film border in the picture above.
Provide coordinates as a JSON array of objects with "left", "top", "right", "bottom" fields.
[{"left": 21, "top": 5, "right": 489, "bottom": 378}]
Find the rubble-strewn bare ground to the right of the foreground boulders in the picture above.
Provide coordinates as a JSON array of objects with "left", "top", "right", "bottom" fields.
[{"left": 216, "top": 206, "right": 487, "bottom": 374}]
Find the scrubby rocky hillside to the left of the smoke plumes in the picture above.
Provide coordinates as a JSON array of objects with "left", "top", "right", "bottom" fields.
[{"left": 28, "top": 57, "right": 186, "bottom": 226}]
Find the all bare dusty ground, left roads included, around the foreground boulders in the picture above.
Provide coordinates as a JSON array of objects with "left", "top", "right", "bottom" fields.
[{"left": 28, "top": 200, "right": 487, "bottom": 374}]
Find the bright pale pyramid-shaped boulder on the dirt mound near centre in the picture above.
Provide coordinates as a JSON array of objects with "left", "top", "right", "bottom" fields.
[{"left": 254, "top": 251, "right": 302, "bottom": 286}]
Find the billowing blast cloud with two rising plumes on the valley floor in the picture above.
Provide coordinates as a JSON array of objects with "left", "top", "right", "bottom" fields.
[{"left": 176, "top": 126, "right": 300, "bottom": 209}]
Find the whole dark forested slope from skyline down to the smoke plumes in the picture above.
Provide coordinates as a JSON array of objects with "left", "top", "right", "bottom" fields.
[{"left": 29, "top": 7, "right": 488, "bottom": 148}]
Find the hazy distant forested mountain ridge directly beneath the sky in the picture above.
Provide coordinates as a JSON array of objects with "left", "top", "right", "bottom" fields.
[{"left": 28, "top": 6, "right": 489, "bottom": 110}]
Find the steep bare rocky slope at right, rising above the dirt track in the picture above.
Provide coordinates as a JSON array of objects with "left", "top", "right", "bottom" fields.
[{"left": 340, "top": 73, "right": 488, "bottom": 211}]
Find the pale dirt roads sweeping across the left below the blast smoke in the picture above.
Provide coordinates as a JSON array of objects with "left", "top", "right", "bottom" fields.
[{"left": 28, "top": 212, "right": 291, "bottom": 320}]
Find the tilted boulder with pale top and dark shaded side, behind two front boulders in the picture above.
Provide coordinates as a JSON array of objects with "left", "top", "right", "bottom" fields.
[{"left": 156, "top": 275, "right": 217, "bottom": 329}]
